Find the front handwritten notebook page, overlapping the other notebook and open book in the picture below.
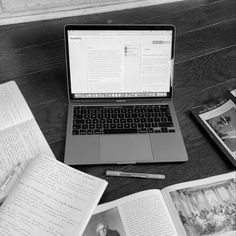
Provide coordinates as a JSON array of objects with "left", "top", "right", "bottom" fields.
[{"left": 0, "top": 157, "right": 107, "bottom": 236}]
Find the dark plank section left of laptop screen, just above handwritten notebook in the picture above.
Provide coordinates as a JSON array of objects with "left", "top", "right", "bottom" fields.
[{"left": 0, "top": 40, "right": 65, "bottom": 80}]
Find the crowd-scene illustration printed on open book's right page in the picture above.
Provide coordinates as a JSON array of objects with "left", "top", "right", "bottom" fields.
[{"left": 170, "top": 178, "right": 236, "bottom": 236}]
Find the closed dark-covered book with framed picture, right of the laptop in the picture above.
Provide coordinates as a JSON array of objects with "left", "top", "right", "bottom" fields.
[{"left": 191, "top": 90, "right": 236, "bottom": 166}]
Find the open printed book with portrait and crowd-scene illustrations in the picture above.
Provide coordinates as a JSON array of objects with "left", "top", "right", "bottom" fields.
[{"left": 83, "top": 172, "right": 236, "bottom": 236}]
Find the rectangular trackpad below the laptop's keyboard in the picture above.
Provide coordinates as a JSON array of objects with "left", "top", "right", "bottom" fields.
[{"left": 100, "top": 135, "right": 153, "bottom": 163}]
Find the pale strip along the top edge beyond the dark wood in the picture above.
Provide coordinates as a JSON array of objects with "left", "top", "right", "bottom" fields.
[{"left": 0, "top": 0, "right": 194, "bottom": 25}]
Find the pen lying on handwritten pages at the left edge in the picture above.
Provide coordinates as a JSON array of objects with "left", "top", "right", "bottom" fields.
[{"left": 0, "top": 162, "right": 21, "bottom": 204}]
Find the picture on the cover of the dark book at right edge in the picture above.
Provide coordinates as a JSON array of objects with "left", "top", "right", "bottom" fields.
[{"left": 207, "top": 107, "right": 236, "bottom": 152}]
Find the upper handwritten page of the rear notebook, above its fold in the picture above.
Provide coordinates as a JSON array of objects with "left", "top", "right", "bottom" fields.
[{"left": 0, "top": 81, "right": 33, "bottom": 131}]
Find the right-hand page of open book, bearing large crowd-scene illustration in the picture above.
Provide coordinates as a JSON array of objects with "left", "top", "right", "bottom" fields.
[{"left": 161, "top": 172, "right": 236, "bottom": 236}]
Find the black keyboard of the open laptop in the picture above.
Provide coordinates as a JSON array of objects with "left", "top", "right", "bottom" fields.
[{"left": 72, "top": 105, "right": 175, "bottom": 135}]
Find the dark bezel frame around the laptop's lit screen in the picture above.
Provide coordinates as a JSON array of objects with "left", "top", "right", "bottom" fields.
[{"left": 64, "top": 25, "right": 176, "bottom": 102}]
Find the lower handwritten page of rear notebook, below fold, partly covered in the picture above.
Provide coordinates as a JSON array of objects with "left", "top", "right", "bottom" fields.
[{"left": 0, "top": 119, "right": 55, "bottom": 185}]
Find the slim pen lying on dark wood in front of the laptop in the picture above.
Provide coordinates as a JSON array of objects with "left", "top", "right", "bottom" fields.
[{"left": 106, "top": 170, "right": 166, "bottom": 179}]
